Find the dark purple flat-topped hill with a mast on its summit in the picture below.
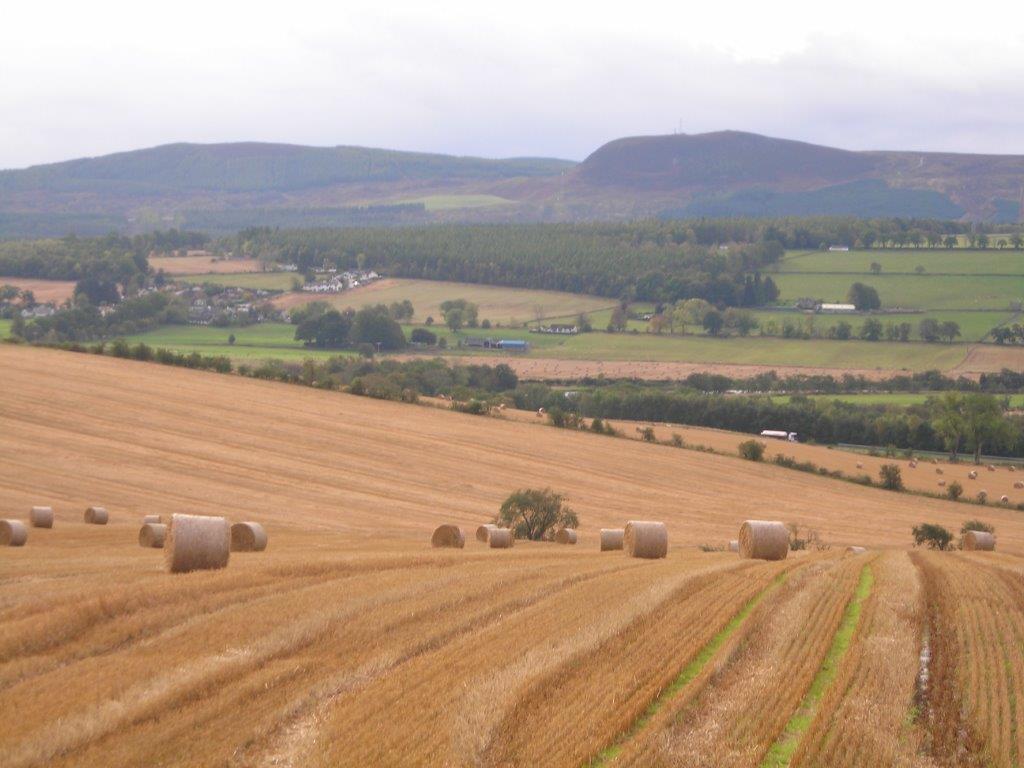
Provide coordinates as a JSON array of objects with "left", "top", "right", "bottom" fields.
[{"left": 571, "top": 131, "right": 1024, "bottom": 221}]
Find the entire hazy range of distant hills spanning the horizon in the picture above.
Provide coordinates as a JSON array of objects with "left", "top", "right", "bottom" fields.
[{"left": 0, "top": 131, "right": 1024, "bottom": 237}]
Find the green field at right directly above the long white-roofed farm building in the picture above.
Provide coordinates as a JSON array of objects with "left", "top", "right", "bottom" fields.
[{"left": 772, "top": 272, "right": 1024, "bottom": 310}]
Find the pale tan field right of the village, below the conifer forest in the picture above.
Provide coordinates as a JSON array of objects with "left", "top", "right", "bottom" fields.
[{"left": 274, "top": 278, "right": 615, "bottom": 325}]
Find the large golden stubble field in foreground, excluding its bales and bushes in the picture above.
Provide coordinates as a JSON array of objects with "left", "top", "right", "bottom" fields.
[{"left": 0, "top": 346, "right": 1024, "bottom": 768}]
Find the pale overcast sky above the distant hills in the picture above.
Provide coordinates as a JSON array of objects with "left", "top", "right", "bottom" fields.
[{"left": 0, "top": 0, "right": 1024, "bottom": 168}]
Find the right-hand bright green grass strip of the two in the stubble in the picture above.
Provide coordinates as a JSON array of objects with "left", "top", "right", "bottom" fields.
[{"left": 761, "top": 565, "right": 874, "bottom": 768}]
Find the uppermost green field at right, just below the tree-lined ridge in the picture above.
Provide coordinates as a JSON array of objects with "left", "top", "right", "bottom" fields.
[{"left": 778, "top": 249, "right": 1024, "bottom": 278}]
